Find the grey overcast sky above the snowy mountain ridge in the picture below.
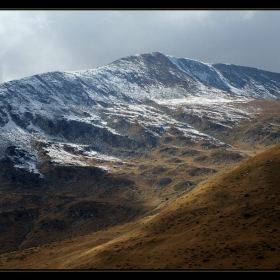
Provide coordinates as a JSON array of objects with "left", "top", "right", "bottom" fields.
[{"left": 0, "top": 9, "right": 280, "bottom": 83}]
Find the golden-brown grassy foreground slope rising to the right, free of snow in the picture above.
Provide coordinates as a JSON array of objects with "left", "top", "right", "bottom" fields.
[{"left": 0, "top": 145, "right": 280, "bottom": 269}]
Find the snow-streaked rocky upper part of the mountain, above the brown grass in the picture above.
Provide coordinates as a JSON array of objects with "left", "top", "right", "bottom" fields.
[{"left": 0, "top": 52, "right": 280, "bottom": 174}]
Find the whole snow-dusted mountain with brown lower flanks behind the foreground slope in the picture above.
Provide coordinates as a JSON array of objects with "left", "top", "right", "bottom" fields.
[{"left": 0, "top": 52, "right": 280, "bottom": 268}]
